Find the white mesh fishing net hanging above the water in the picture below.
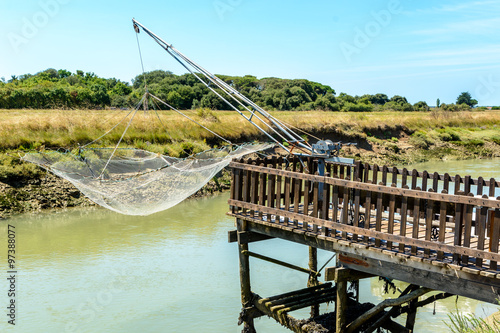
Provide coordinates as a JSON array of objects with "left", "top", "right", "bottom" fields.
[{"left": 22, "top": 143, "right": 273, "bottom": 215}]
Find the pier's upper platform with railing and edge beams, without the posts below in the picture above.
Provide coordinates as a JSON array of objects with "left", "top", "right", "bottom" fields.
[{"left": 229, "top": 158, "right": 500, "bottom": 303}]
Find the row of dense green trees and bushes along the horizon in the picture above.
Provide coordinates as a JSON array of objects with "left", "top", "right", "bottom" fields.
[{"left": 0, "top": 68, "right": 477, "bottom": 111}]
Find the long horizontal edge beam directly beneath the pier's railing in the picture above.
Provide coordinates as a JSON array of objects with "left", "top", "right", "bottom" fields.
[{"left": 236, "top": 219, "right": 500, "bottom": 304}]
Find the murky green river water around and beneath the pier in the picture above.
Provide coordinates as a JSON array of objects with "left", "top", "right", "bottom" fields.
[{"left": 0, "top": 160, "right": 500, "bottom": 333}]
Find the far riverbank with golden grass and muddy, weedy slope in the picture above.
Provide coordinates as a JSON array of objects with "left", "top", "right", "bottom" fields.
[{"left": 0, "top": 110, "right": 500, "bottom": 218}]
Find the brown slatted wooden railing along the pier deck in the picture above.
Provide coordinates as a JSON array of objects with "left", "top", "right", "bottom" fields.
[{"left": 229, "top": 157, "right": 500, "bottom": 271}]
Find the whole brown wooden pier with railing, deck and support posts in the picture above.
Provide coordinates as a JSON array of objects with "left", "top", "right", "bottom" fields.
[{"left": 228, "top": 157, "right": 500, "bottom": 332}]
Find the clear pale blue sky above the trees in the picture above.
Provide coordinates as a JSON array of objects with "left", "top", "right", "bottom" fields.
[{"left": 0, "top": 0, "right": 500, "bottom": 105}]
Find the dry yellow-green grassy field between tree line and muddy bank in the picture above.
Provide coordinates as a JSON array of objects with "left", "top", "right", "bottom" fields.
[{"left": 0, "top": 110, "right": 500, "bottom": 169}]
